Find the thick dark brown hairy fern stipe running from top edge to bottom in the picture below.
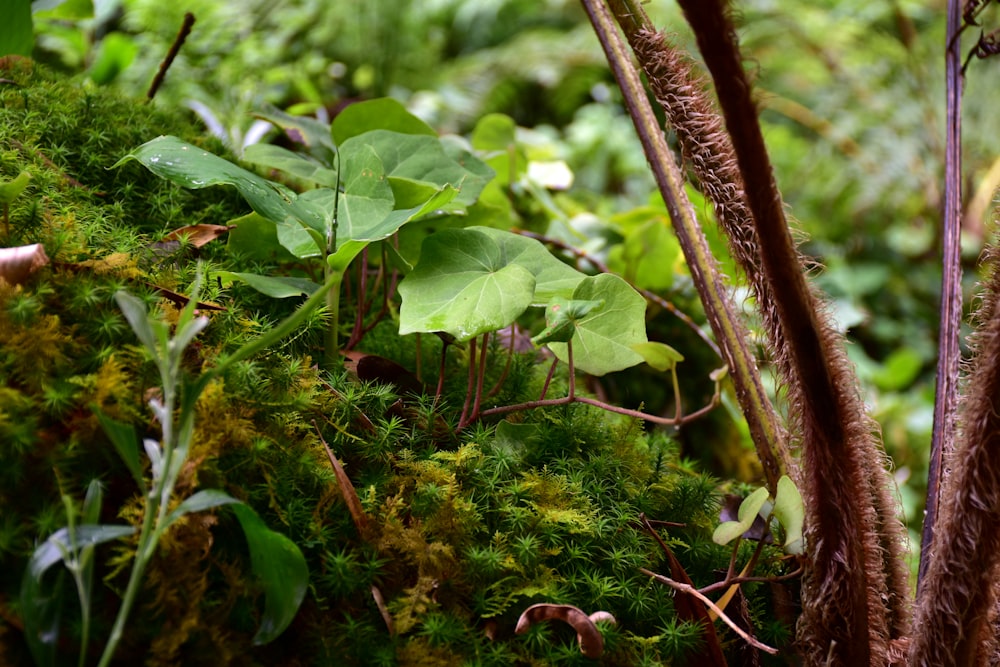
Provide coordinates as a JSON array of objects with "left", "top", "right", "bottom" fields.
[{"left": 680, "top": 0, "right": 908, "bottom": 665}]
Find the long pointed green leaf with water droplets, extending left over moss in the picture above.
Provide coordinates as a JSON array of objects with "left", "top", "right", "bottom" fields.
[{"left": 112, "top": 136, "right": 322, "bottom": 228}]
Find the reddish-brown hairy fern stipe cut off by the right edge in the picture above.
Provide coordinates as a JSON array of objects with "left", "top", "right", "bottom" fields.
[{"left": 910, "top": 249, "right": 1000, "bottom": 667}]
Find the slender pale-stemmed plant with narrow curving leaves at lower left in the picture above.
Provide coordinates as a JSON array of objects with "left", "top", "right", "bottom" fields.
[{"left": 21, "top": 270, "right": 332, "bottom": 666}]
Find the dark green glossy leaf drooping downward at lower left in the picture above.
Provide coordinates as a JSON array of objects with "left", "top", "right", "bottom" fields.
[{"left": 233, "top": 504, "right": 309, "bottom": 645}]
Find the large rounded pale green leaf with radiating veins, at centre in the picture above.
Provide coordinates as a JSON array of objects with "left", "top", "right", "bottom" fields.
[{"left": 399, "top": 229, "right": 535, "bottom": 341}]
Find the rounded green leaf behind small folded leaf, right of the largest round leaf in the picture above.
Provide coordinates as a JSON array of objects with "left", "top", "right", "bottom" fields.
[{"left": 549, "top": 273, "right": 646, "bottom": 375}]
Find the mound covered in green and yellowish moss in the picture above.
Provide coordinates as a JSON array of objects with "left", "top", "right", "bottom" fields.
[{"left": 0, "top": 60, "right": 789, "bottom": 666}]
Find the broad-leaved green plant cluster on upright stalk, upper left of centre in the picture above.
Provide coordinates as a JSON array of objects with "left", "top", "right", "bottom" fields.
[{"left": 119, "top": 99, "right": 490, "bottom": 366}]
